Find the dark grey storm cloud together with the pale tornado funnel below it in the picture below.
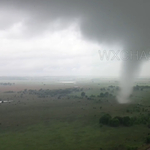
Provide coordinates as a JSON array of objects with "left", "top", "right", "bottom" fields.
[{"left": 0, "top": 0, "right": 150, "bottom": 102}]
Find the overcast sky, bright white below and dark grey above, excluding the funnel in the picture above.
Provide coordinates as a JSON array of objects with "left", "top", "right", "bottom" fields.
[{"left": 0, "top": 0, "right": 150, "bottom": 77}]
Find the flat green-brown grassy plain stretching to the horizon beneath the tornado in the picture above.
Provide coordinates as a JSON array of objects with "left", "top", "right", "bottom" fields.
[{"left": 0, "top": 81, "right": 150, "bottom": 150}]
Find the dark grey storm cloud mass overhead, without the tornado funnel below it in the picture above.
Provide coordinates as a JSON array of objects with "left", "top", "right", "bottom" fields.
[{"left": 1, "top": 0, "right": 150, "bottom": 47}]
